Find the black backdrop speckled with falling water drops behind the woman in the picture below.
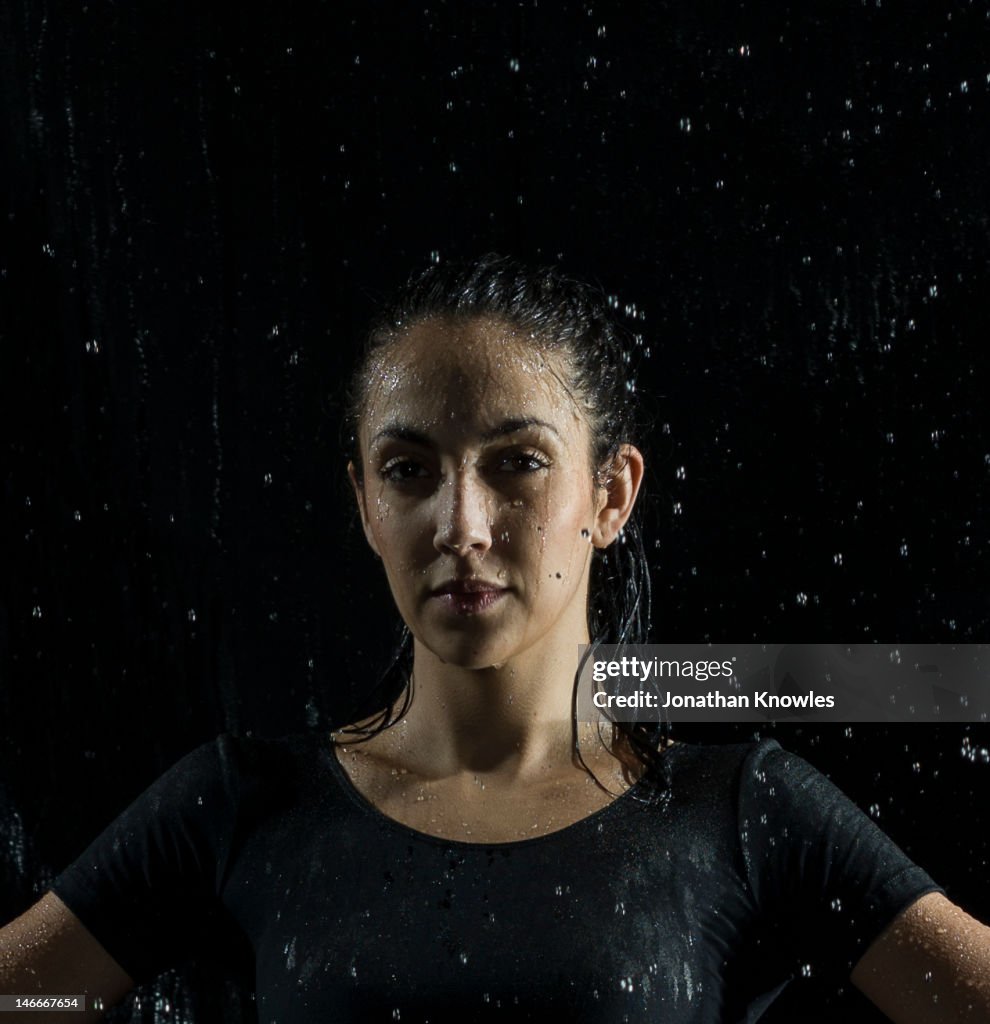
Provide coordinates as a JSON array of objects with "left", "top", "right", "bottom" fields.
[{"left": 0, "top": 0, "right": 990, "bottom": 1021}]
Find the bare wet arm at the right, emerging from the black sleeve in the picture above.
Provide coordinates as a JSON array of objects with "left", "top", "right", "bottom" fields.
[{"left": 852, "top": 893, "right": 990, "bottom": 1024}]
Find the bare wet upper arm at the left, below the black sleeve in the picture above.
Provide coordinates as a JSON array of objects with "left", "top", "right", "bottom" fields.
[{"left": 0, "top": 892, "right": 134, "bottom": 1024}]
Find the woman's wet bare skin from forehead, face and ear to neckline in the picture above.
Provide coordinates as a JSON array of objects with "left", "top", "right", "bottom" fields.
[{"left": 341, "top": 321, "right": 642, "bottom": 841}]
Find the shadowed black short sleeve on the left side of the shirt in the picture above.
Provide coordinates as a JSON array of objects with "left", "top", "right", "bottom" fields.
[{"left": 51, "top": 734, "right": 239, "bottom": 983}]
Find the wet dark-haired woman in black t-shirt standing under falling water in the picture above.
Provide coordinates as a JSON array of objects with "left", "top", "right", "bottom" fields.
[{"left": 0, "top": 257, "right": 990, "bottom": 1024}]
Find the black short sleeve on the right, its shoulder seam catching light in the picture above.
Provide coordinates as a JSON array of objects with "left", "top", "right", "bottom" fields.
[{"left": 739, "top": 739, "right": 943, "bottom": 976}]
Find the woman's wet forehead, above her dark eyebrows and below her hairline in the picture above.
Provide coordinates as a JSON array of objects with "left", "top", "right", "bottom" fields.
[{"left": 362, "top": 319, "right": 582, "bottom": 430}]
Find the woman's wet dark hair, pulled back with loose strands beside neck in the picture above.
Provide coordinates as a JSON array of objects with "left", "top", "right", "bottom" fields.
[{"left": 346, "top": 254, "right": 670, "bottom": 793}]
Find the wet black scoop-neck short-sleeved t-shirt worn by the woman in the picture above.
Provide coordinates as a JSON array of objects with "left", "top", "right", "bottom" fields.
[{"left": 53, "top": 734, "right": 939, "bottom": 1024}]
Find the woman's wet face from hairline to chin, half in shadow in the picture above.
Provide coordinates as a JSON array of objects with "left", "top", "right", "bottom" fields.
[{"left": 351, "top": 319, "right": 611, "bottom": 668}]
